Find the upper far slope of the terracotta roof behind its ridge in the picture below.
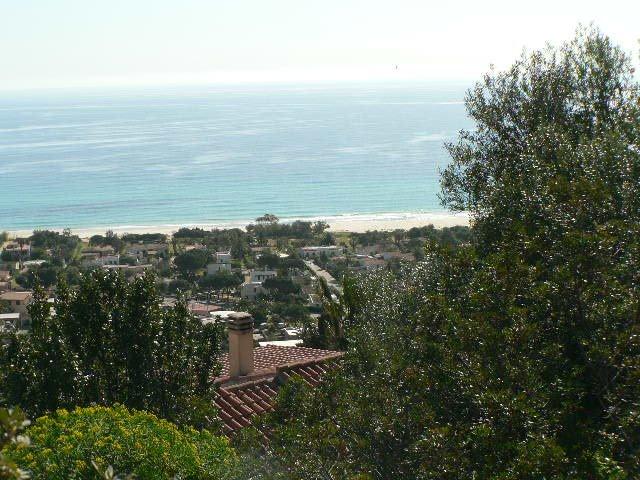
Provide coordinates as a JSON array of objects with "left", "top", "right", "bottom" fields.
[{"left": 220, "top": 345, "right": 340, "bottom": 377}]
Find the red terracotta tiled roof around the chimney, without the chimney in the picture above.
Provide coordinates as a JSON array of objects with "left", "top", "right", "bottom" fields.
[{"left": 214, "top": 345, "right": 342, "bottom": 438}]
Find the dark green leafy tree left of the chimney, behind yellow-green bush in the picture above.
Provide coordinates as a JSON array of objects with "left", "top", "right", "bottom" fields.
[{"left": 0, "top": 270, "right": 220, "bottom": 427}]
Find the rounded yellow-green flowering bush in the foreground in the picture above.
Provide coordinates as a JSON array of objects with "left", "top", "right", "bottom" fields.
[{"left": 5, "top": 405, "right": 236, "bottom": 480}]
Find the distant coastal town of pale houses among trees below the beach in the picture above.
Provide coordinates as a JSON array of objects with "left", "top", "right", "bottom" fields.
[{"left": 0, "top": 214, "right": 469, "bottom": 346}]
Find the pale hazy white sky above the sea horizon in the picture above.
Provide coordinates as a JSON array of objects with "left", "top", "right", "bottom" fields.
[{"left": 0, "top": 0, "right": 640, "bottom": 89}]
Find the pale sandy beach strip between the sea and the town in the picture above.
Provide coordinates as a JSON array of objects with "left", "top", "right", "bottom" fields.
[{"left": 2, "top": 212, "right": 469, "bottom": 238}]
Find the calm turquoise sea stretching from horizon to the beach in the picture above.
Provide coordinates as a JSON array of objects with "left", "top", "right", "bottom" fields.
[{"left": 0, "top": 84, "right": 471, "bottom": 230}]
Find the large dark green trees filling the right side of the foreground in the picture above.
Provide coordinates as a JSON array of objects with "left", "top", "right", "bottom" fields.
[{"left": 239, "top": 27, "right": 640, "bottom": 480}]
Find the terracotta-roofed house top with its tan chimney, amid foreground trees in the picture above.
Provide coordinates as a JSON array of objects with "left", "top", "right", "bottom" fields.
[{"left": 214, "top": 312, "right": 342, "bottom": 436}]
